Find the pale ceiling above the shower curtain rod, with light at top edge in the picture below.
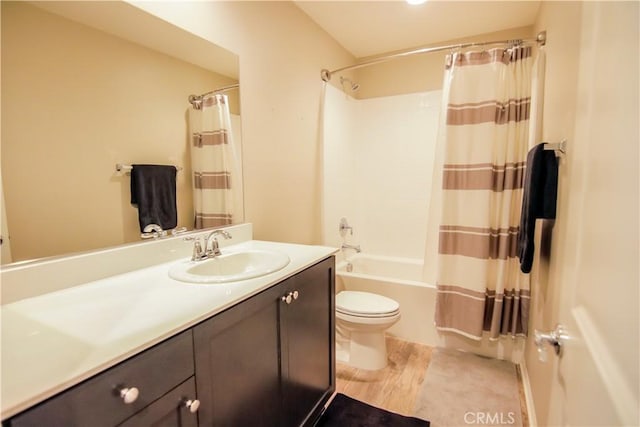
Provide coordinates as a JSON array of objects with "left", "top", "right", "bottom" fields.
[{"left": 295, "top": 0, "right": 540, "bottom": 58}]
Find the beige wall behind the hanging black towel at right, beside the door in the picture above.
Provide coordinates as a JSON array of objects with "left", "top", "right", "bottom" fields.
[{"left": 525, "top": 2, "right": 582, "bottom": 425}]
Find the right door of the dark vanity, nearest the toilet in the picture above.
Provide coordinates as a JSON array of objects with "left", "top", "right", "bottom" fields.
[{"left": 281, "top": 257, "right": 335, "bottom": 426}]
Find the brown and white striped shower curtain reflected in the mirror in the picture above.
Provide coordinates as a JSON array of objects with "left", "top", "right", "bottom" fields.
[{"left": 189, "top": 94, "right": 240, "bottom": 229}]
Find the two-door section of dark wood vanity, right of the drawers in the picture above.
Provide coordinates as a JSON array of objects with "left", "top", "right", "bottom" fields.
[{"left": 193, "top": 257, "right": 335, "bottom": 427}]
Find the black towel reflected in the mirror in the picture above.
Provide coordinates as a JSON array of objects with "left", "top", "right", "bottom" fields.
[{"left": 131, "top": 165, "right": 178, "bottom": 232}]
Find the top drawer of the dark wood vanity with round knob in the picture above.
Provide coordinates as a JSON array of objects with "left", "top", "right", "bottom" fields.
[{"left": 10, "top": 330, "right": 194, "bottom": 427}]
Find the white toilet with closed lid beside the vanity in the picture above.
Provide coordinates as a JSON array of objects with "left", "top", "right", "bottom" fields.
[{"left": 336, "top": 291, "right": 400, "bottom": 370}]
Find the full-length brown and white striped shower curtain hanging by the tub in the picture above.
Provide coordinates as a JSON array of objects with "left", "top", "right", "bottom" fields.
[{"left": 435, "top": 47, "right": 532, "bottom": 339}]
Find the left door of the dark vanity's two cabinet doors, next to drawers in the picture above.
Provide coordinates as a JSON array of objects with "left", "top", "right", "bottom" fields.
[{"left": 194, "top": 285, "right": 281, "bottom": 427}]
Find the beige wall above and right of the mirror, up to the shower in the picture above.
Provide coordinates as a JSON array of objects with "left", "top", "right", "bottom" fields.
[{"left": 136, "top": 1, "right": 354, "bottom": 243}]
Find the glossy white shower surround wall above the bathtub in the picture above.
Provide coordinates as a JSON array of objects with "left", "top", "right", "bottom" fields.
[{"left": 323, "top": 86, "right": 441, "bottom": 259}]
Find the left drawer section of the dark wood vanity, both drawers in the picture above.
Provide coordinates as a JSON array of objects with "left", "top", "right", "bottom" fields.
[{"left": 4, "top": 330, "right": 197, "bottom": 427}]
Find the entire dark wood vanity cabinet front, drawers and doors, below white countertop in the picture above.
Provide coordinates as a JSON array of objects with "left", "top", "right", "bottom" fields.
[{"left": 3, "top": 257, "right": 335, "bottom": 427}]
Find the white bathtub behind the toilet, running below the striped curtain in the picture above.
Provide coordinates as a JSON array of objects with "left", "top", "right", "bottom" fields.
[{"left": 336, "top": 253, "right": 525, "bottom": 363}]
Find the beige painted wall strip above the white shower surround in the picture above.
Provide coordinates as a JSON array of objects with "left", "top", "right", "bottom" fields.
[{"left": 356, "top": 27, "right": 535, "bottom": 99}]
